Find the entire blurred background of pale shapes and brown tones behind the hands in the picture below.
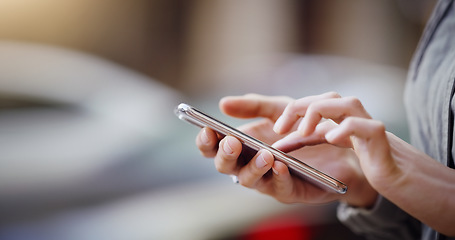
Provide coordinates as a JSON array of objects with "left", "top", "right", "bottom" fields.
[{"left": 0, "top": 0, "right": 435, "bottom": 240}]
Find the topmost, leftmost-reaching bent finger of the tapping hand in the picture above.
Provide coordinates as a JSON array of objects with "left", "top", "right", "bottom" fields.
[{"left": 273, "top": 92, "right": 341, "bottom": 134}]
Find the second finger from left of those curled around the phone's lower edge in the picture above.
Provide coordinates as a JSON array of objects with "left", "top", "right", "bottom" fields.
[{"left": 214, "top": 136, "right": 242, "bottom": 175}]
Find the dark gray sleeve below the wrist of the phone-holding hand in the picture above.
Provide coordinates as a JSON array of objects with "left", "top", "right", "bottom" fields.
[{"left": 337, "top": 196, "right": 421, "bottom": 240}]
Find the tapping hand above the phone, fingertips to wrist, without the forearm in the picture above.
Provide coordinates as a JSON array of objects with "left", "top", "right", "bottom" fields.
[{"left": 274, "top": 92, "right": 399, "bottom": 184}]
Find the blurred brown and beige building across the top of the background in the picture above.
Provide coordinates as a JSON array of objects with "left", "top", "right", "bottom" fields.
[{"left": 0, "top": 0, "right": 434, "bottom": 95}]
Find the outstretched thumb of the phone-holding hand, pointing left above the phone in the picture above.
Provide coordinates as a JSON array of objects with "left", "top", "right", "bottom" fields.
[{"left": 220, "top": 94, "right": 292, "bottom": 121}]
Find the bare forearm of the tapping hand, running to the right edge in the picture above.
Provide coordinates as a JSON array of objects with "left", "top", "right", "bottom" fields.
[{"left": 372, "top": 134, "right": 455, "bottom": 236}]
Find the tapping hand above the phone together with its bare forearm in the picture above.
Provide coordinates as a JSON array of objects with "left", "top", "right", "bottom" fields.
[{"left": 274, "top": 93, "right": 455, "bottom": 235}]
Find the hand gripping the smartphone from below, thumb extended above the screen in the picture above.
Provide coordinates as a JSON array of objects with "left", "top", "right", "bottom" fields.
[{"left": 196, "top": 95, "right": 377, "bottom": 206}]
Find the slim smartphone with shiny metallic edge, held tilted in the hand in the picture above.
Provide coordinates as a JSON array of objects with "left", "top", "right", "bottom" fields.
[{"left": 174, "top": 103, "right": 348, "bottom": 194}]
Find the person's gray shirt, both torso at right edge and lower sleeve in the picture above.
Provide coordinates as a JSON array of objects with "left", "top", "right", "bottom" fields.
[{"left": 338, "top": 0, "right": 455, "bottom": 240}]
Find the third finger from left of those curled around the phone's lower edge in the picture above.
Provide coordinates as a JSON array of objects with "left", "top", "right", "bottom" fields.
[{"left": 238, "top": 150, "right": 274, "bottom": 188}]
